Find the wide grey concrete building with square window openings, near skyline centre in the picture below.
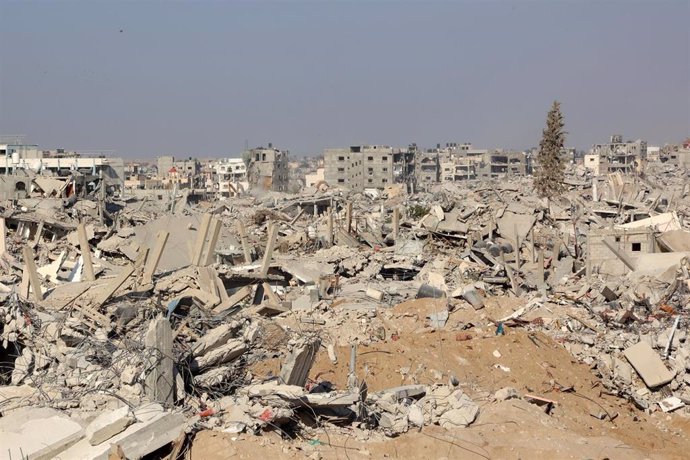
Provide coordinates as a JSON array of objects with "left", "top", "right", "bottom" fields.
[{"left": 324, "top": 145, "right": 416, "bottom": 190}]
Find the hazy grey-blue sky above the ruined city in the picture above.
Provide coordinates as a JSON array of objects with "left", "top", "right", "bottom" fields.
[{"left": 0, "top": 0, "right": 690, "bottom": 158}]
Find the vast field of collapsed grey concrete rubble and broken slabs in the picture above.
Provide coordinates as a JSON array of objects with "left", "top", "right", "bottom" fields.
[{"left": 0, "top": 164, "right": 690, "bottom": 458}]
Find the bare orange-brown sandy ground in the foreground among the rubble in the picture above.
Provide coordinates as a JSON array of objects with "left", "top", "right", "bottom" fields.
[{"left": 191, "top": 296, "right": 690, "bottom": 459}]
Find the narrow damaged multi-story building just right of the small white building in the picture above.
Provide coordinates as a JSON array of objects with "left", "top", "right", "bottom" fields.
[{"left": 245, "top": 143, "right": 290, "bottom": 192}]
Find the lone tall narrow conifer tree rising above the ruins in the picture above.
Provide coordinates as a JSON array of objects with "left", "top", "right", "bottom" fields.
[{"left": 534, "top": 101, "right": 565, "bottom": 199}]
